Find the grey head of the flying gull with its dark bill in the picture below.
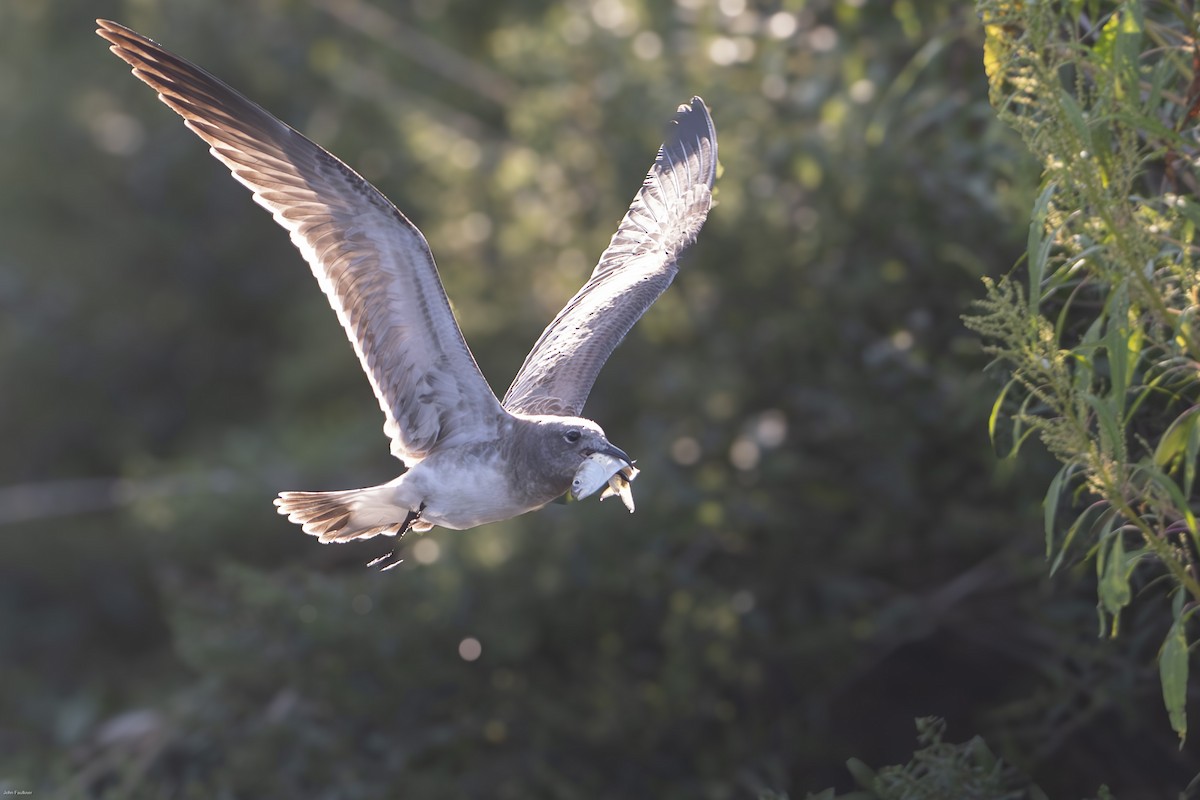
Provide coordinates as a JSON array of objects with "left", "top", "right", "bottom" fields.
[{"left": 514, "top": 416, "right": 632, "bottom": 503}]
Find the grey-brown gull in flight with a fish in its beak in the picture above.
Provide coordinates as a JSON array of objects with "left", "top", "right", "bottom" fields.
[{"left": 96, "top": 19, "right": 716, "bottom": 556}]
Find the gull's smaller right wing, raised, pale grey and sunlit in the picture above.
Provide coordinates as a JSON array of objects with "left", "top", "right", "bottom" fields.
[{"left": 504, "top": 97, "right": 716, "bottom": 416}]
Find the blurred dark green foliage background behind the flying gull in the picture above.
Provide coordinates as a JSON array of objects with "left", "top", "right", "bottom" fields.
[{"left": 0, "top": 0, "right": 1196, "bottom": 799}]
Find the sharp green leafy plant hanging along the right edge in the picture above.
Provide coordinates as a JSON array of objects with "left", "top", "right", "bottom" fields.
[{"left": 966, "top": 0, "right": 1200, "bottom": 741}]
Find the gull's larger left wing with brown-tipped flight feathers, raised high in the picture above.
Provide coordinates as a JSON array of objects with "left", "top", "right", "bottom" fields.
[{"left": 96, "top": 19, "right": 504, "bottom": 465}]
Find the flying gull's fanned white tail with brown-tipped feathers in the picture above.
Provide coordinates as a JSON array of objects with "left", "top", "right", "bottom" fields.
[{"left": 275, "top": 485, "right": 432, "bottom": 543}]
